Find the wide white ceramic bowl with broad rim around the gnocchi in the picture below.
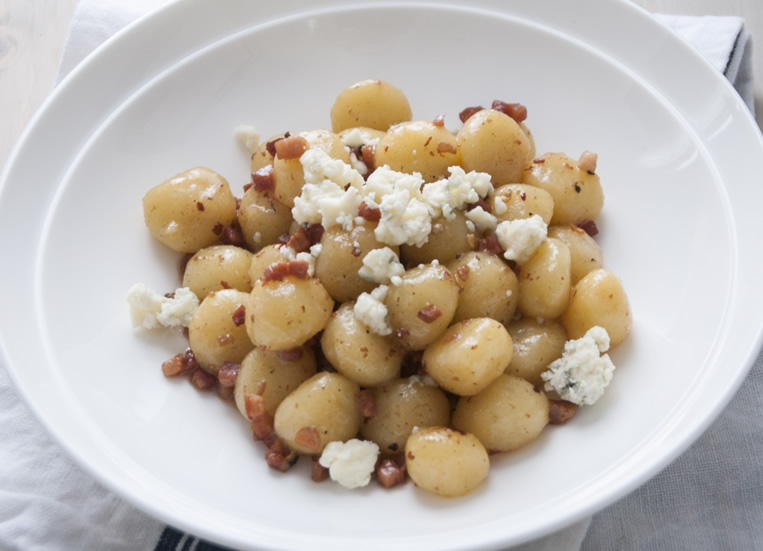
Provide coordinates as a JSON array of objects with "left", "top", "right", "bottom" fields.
[{"left": 0, "top": 0, "right": 763, "bottom": 550}]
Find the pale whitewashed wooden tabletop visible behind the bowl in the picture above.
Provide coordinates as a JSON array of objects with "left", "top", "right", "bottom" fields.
[{"left": 0, "top": 0, "right": 763, "bottom": 171}]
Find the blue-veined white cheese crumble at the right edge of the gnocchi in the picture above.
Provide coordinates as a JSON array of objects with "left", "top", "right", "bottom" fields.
[{"left": 541, "top": 326, "right": 615, "bottom": 405}]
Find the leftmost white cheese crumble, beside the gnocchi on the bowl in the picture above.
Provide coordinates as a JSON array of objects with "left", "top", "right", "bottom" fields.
[{"left": 127, "top": 283, "right": 199, "bottom": 329}]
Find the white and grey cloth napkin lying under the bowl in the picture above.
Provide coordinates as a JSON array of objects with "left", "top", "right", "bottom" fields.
[{"left": 0, "top": 0, "right": 763, "bottom": 551}]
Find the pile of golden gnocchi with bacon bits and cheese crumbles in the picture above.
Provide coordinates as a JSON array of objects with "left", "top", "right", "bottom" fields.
[{"left": 128, "top": 80, "right": 632, "bottom": 497}]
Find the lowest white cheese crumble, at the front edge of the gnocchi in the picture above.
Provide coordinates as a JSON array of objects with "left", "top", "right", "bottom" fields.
[{"left": 318, "top": 438, "right": 379, "bottom": 489}]
